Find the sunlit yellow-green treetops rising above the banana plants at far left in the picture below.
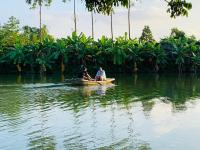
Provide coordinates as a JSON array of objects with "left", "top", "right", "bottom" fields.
[{"left": 0, "top": 16, "right": 53, "bottom": 48}]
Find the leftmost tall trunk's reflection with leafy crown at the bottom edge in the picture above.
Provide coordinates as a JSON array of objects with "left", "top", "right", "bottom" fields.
[{"left": 28, "top": 92, "right": 56, "bottom": 150}]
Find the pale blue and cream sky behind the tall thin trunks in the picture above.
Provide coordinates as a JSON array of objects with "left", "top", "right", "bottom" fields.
[{"left": 0, "top": 0, "right": 200, "bottom": 40}]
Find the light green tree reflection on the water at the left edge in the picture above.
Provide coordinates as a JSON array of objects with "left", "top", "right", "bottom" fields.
[{"left": 0, "top": 85, "right": 26, "bottom": 131}]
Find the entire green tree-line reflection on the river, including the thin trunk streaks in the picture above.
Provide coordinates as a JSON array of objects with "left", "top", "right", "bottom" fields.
[{"left": 0, "top": 74, "right": 200, "bottom": 150}]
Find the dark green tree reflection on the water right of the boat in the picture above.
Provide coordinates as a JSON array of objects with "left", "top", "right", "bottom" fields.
[{"left": 113, "top": 74, "right": 200, "bottom": 110}]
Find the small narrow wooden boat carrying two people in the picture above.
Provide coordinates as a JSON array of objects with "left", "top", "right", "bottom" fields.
[{"left": 65, "top": 78, "right": 115, "bottom": 86}]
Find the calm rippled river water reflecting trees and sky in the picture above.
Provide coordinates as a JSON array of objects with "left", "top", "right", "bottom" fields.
[{"left": 0, "top": 74, "right": 200, "bottom": 150}]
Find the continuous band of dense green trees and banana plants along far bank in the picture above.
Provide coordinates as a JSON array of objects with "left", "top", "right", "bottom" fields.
[{"left": 0, "top": 17, "right": 200, "bottom": 73}]
